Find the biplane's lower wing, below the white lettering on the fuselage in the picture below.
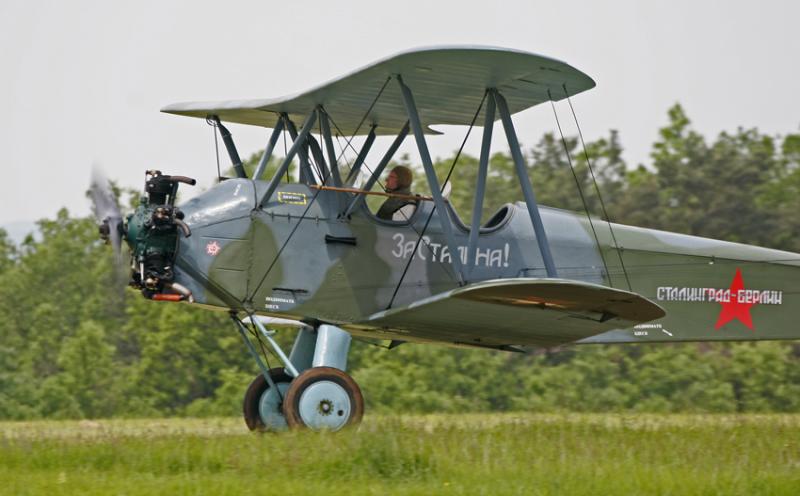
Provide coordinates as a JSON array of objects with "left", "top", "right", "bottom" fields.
[{"left": 346, "top": 278, "right": 665, "bottom": 349}]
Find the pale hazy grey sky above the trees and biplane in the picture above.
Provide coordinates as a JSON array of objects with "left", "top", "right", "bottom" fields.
[{"left": 0, "top": 0, "right": 800, "bottom": 224}]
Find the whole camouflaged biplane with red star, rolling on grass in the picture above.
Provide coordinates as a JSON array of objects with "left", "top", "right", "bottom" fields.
[{"left": 90, "top": 46, "right": 800, "bottom": 430}]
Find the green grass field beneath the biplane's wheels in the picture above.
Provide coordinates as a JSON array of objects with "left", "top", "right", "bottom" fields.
[{"left": 0, "top": 414, "right": 800, "bottom": 496}]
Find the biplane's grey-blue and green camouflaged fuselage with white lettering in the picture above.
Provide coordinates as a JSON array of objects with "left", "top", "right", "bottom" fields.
[{"left": 164, "top": 179, "right": 800, "bottom": 343}]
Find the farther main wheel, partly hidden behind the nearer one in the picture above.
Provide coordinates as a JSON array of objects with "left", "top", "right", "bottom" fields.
[{"left": 243, "top": 368, "right": 292, "bottom": 431}]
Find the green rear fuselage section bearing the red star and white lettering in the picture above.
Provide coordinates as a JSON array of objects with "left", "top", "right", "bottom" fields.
[{"left": 580, "top": 226, "right": 800, "bottom": 343}]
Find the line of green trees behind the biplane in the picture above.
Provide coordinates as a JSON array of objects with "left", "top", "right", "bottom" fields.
[{"left": 0, "top": 105, "right": 800, "bottom": 419}]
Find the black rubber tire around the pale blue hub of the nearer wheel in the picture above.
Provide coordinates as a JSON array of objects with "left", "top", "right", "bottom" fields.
[{"left": 283, "top": 367, "right": 364, "bottom": 429}]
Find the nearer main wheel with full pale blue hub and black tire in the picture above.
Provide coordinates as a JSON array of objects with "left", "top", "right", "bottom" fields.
[{"left": 283, "top": 367, "right": 364, "bottom": 431}]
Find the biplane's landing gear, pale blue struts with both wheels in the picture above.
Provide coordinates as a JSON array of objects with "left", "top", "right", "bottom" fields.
[{"left": 234, "top": 317, "right": 364, "bottom": 431}]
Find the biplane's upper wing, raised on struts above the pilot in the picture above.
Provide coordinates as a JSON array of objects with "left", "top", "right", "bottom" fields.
[{"left": 162, "top": 46, "right": 595, "bottom": 135}]
